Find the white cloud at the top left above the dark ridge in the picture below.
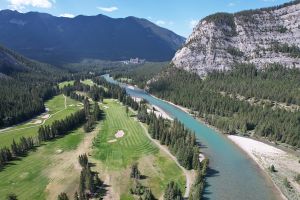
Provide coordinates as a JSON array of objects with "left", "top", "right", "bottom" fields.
[{"left": 8, "top": 0, "right": 54, "bottom": 10}]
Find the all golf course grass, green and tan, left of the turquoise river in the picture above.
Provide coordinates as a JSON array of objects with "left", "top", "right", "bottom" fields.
[{"left": 0, "top": 79, "right": 193, "bottom": 199}]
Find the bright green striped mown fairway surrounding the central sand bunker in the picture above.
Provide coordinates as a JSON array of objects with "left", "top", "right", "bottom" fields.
[{"left": 94, "top": 100, "right": 158, "bottom": 169}]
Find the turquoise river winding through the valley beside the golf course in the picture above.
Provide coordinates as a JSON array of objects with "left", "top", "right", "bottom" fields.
[{"left": 104, "top": 75, "right": 279, "bottom": 200}]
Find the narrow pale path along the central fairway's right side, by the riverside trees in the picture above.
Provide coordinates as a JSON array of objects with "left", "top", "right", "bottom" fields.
[{"left": 140, "top": 122, "right": 195, "bottom": 198}]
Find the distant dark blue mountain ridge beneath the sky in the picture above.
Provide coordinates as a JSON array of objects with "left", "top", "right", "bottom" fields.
[{"left": 0, "top": 10, "right": 185, "bottom": 64}]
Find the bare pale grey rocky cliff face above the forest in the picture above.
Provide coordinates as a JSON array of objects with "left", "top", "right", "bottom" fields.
[{"left": 172, "top": 0, "right": 300, "bottom": 76}]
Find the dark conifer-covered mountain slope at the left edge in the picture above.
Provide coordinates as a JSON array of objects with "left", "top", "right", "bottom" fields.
[{"left": 0, "top": 46, "right": 66, "bottom": 127}]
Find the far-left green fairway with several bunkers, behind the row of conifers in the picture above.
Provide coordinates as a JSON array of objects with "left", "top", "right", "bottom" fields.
[{"left": 0, "top": 95, "right": 81, "bottom": 148}]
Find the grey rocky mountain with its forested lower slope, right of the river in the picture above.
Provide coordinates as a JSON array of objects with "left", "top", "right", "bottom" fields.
[{"left": 149, "top": 0, "right": 300, "bottom": 148}]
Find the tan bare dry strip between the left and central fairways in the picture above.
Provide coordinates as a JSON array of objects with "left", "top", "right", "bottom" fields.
[{"left": 45, "top": 127, "right": 100, "bottom": 200}]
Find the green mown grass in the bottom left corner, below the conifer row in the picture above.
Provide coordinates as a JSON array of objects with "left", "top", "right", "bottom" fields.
[{"left": 0, "top": 129, "right": 84, "bottom": 200}]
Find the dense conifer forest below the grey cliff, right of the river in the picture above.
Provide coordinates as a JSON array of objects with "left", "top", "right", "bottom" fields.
[{"left": 150, "top": 65, "right": 300, "bottom": 148}]
